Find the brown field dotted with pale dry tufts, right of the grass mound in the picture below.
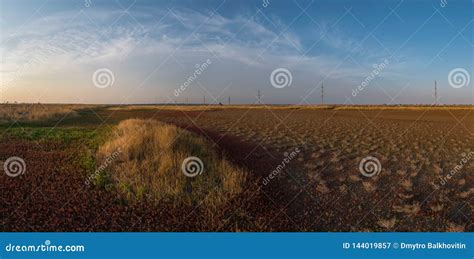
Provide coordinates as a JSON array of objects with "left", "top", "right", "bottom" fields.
[{"left": 156, "top": 108, "right": 474, "bottom": 231}]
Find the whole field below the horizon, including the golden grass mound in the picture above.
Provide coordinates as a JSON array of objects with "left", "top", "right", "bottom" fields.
[{"left": 0, "top": 105, "right": 474, "bottom": 232}]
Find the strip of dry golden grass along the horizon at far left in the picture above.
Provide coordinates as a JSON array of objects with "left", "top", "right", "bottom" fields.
[{"left": 0, "top": 103, "right": 91, "bottom": 123}]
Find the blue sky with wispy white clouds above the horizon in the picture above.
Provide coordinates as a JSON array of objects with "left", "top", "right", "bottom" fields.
[{"left": 0, "top": 0, "right": 474, "bottom": 104}]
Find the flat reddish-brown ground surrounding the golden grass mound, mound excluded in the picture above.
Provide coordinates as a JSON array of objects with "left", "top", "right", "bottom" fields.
[{"left": 0, "top": 106, "right": 474, "bottom": 231}]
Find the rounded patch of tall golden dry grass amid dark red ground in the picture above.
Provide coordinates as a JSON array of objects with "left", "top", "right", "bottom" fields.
[{"left": 98, "top": 119, "right": 247, "bottom": 211}]
